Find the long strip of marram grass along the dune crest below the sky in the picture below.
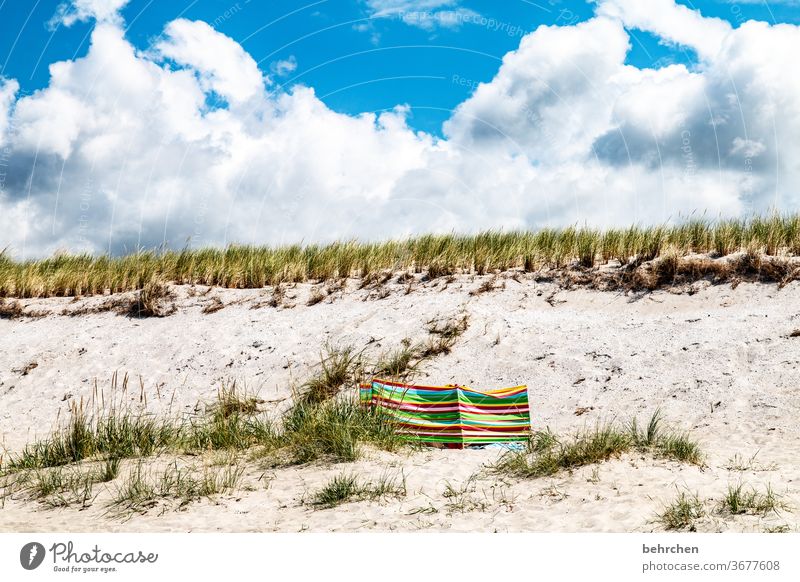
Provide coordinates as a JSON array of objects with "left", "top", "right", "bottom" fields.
[{"left": 0, "top": 214, "right": 800, "bottom": 298}]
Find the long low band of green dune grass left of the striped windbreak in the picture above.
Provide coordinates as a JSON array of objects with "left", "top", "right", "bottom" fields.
[{"left": 0, "top": 391, "right": 396, "bottom": 474}]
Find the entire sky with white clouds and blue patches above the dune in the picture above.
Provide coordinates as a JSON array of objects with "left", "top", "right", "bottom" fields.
[{"left": 0, "top": 0, "right": 800, "bottom": 258}]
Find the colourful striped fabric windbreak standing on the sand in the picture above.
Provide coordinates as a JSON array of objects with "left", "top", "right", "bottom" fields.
[{"left": 360, "top": 379, "right": 531, "bottom": 448}]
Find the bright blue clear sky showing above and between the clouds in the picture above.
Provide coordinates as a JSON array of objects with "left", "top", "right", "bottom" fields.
[{"left": 0, "top": 0, "right": 800, "bottom": 134}]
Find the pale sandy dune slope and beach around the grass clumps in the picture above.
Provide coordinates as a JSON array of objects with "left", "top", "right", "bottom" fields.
[{"left": 0, "top": 276, "right": 800, "bottom": 531}]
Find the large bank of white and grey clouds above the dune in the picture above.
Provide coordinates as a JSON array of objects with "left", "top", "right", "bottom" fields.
[{"left": 0, "top": 0, "right": 800, "bottom": 257}]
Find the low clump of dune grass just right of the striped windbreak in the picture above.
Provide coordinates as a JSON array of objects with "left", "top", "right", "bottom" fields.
[{"left": 493, "top": 410, "right": 702, "bottom": 478}]
